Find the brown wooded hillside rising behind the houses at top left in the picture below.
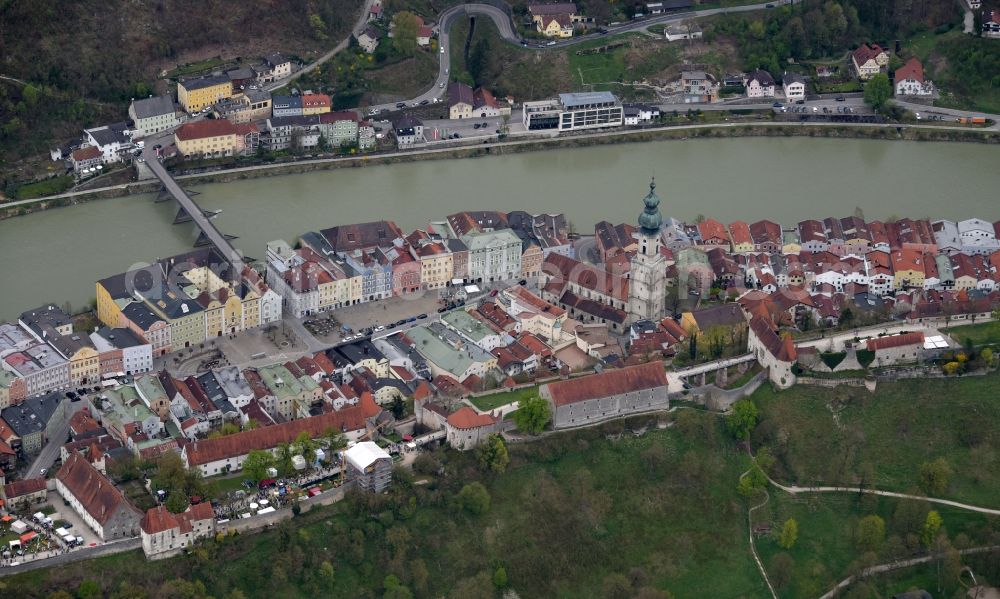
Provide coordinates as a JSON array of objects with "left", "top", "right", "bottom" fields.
[{"left": 0, "top": 0, "right": 363, "bottom": 177}]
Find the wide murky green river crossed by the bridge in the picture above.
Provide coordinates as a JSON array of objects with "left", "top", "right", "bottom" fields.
[{"left": 0, "top": 137, "right": 1000, "bottom": 319}]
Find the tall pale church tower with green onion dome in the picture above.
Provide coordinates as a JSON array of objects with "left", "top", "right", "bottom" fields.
[{"left": 628, "top": 179, "right": 667, "bottom": 323}]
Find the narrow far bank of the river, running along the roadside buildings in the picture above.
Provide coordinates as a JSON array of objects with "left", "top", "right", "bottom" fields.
[{"left": 0, "top": 122, "right": 1000, "bottom": 220}]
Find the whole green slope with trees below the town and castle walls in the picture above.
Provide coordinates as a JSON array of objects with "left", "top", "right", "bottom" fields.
[{"left": 0, "top": 374, "right": 1000, "bottom": 599}]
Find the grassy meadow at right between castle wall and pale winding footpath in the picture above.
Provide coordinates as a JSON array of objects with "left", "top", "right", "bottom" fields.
[{"left": 752, "top": 373, "right": 1000, "bottom": 508}]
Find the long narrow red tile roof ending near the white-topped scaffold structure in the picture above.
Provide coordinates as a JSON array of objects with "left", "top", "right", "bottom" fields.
[{"left": 184, "top": 394, "right": 382, "bottom": 466}]
